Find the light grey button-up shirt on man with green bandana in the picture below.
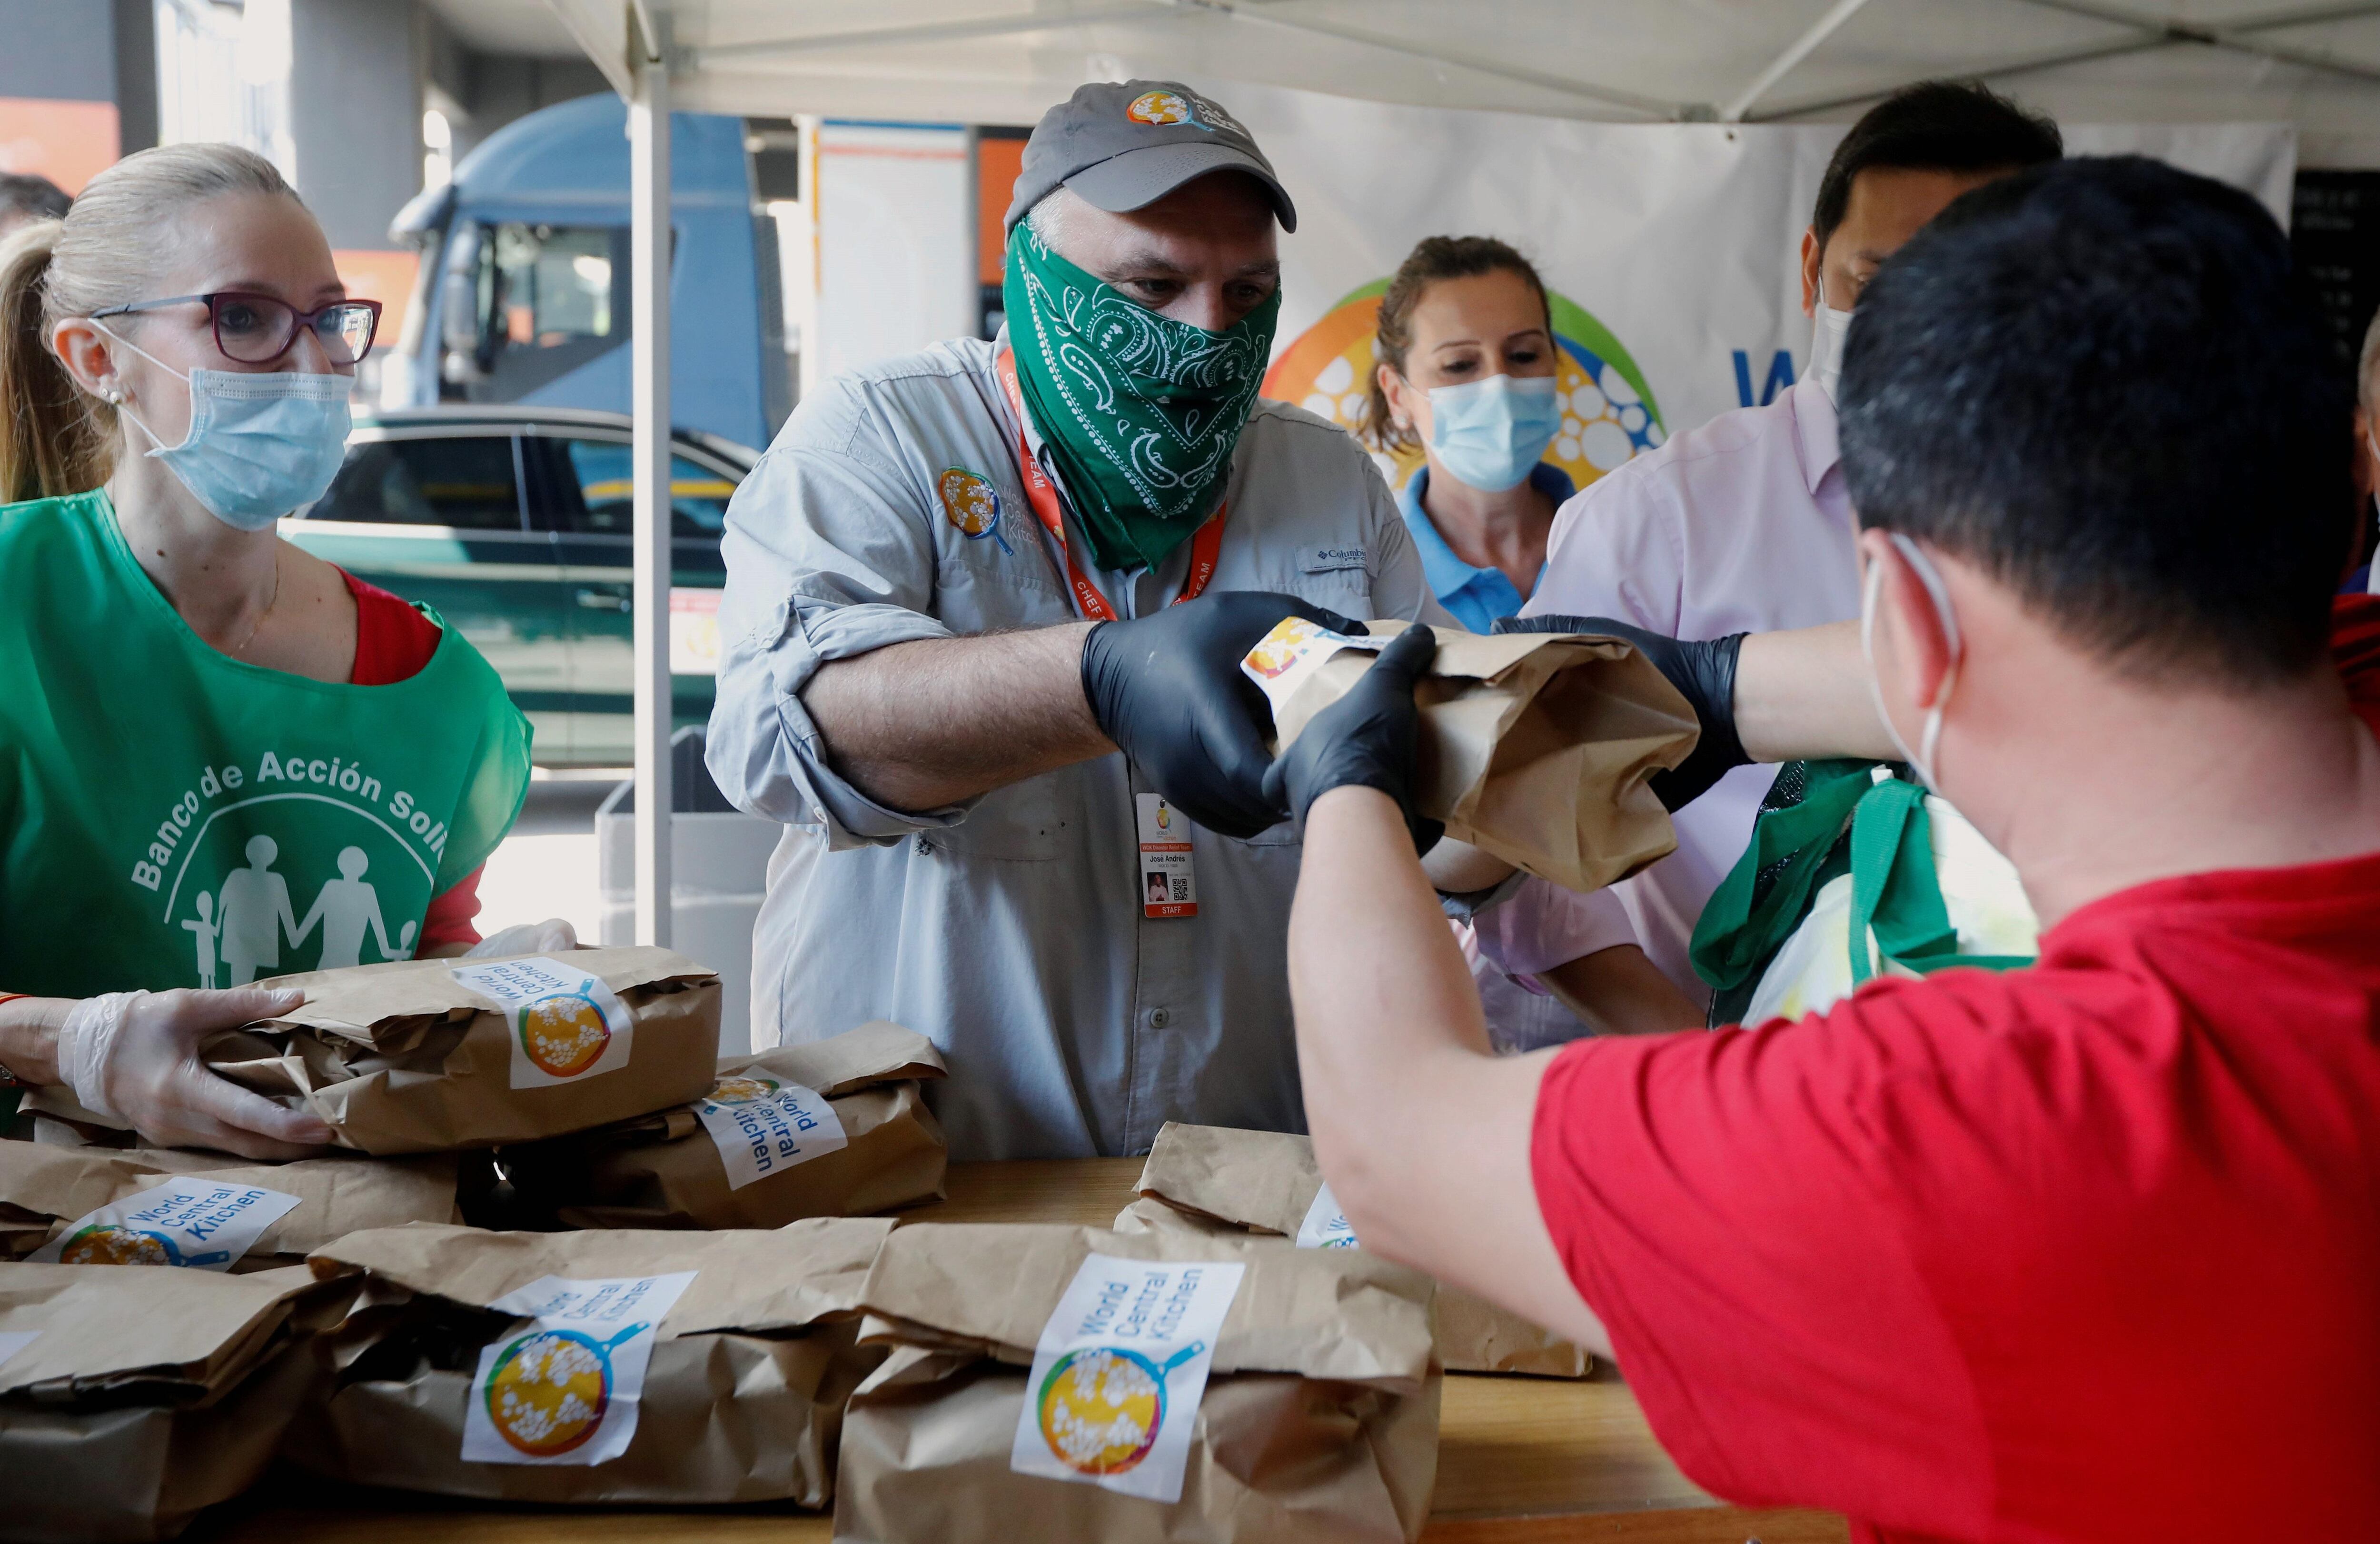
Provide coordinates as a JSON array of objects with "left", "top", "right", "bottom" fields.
[{"left": 709, "top": 340, "right": 1452, "bottom": 1158}]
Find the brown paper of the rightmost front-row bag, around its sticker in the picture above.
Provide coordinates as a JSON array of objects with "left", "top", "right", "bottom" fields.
[{"left": 835, "top": 1223, "right": 1440, "bottom": 1544}]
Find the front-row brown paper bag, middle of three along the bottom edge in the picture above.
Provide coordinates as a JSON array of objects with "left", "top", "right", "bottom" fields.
[{"left": 283, "top": 1218, "right": 892, "bottom": 1506}]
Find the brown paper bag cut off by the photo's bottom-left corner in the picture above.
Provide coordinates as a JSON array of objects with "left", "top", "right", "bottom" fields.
[{"left": 0, "top": 1256, "right": 355, "bottom": 1542}]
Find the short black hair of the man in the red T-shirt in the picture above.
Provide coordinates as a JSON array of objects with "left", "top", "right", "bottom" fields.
[{"left": 1840, "top": 157, "right": 2354, "bottom": 685}]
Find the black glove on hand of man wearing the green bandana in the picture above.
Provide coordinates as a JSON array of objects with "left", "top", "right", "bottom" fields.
[{"left": 1083, "top": 590, "right": 1364, "bottom": 837}]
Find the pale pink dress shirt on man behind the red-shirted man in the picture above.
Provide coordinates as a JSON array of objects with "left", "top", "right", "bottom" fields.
[{"left": 1478, "top": 381, "right": 1859, "bottom": 1002}]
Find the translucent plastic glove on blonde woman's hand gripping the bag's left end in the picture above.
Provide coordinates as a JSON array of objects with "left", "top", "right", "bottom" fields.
[{"left": 57, "top": 987, "right": 331, "bottom": 1158}]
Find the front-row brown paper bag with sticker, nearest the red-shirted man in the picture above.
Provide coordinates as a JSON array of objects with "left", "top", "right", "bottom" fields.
[{"left": 835, "top": 1223, "right": 1440, "bottom": 1544}]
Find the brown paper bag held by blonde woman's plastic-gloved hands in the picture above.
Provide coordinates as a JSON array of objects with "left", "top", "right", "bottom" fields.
[{"left": 187, "top": 949, "right": 719, "bottom": 1154}]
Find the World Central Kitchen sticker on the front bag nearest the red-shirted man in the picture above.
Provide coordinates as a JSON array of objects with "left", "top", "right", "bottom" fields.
[{"left": 1009, "top": 1254, "right": 1247, "bottom": 1501}]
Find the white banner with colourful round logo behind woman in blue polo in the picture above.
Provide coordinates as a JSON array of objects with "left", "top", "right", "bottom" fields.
[{"left": 1216, "top": 86, "right": 2297, "bottom": 485}]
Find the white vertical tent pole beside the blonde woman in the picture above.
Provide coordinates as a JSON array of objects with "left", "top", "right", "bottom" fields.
[{"left": 628, "top": 5, "right": 671, "bottom": 947}]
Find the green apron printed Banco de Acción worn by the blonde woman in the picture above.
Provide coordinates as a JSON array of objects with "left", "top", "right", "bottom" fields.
[{"left": 0, "top": 492, "right": 528, "bottom": 997}]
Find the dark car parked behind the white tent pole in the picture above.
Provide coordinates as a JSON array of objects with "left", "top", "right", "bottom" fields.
[{"left": 281, "top": 404, "right": 754, "bottom": 766}]
